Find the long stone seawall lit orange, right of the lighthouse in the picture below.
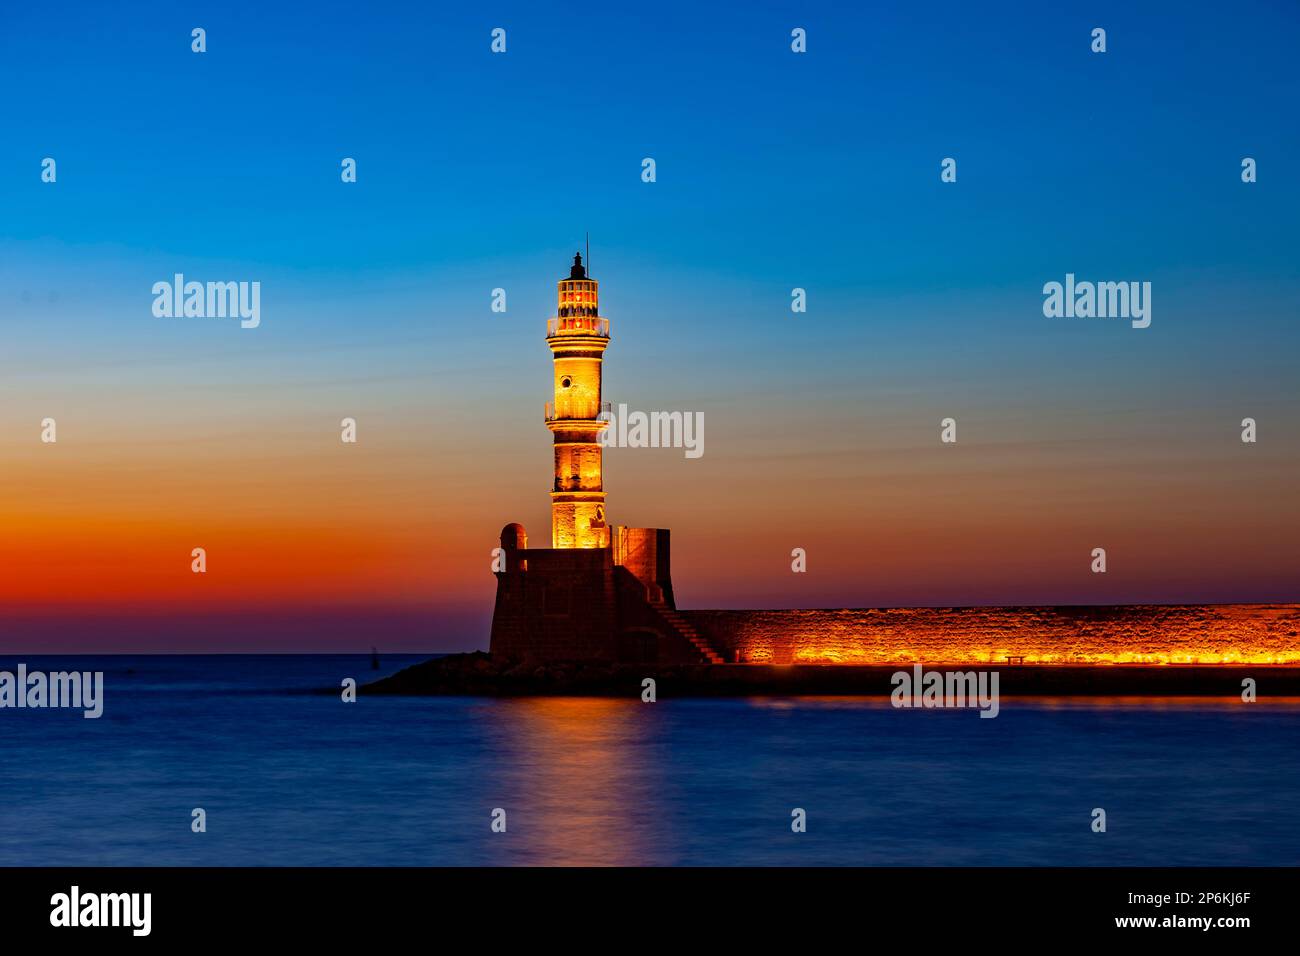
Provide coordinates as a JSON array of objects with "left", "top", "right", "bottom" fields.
[{"left": 680, "top": 604, "right": 1300, "bottom": 665}]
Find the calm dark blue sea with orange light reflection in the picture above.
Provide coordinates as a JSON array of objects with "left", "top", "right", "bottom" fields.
[{"left": 0, "top": 656, "right": 1300, "bottom": 865}]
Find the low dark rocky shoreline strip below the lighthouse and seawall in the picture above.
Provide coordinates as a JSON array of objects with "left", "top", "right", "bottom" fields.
[{"left": 359, "top": 652, "right": 1300, "bottom": 701}]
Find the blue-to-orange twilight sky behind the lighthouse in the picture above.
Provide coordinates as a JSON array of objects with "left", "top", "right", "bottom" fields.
[{"left": 0, "top": 3, "right": 1300, "bottom": 652}]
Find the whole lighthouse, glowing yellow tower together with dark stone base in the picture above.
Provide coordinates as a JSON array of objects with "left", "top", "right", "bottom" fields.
[{"left": 489, "top": 254, "right": 724, "bottom": 663}]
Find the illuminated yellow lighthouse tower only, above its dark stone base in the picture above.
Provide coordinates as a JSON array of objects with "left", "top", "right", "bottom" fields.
[{"left": 546, "top": 252, "right": 610, "bottom": 548}]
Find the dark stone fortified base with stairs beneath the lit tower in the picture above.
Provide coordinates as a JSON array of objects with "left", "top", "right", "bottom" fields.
[{"left": 490, "top": 524, "right": 723, "bottom": 663}]
